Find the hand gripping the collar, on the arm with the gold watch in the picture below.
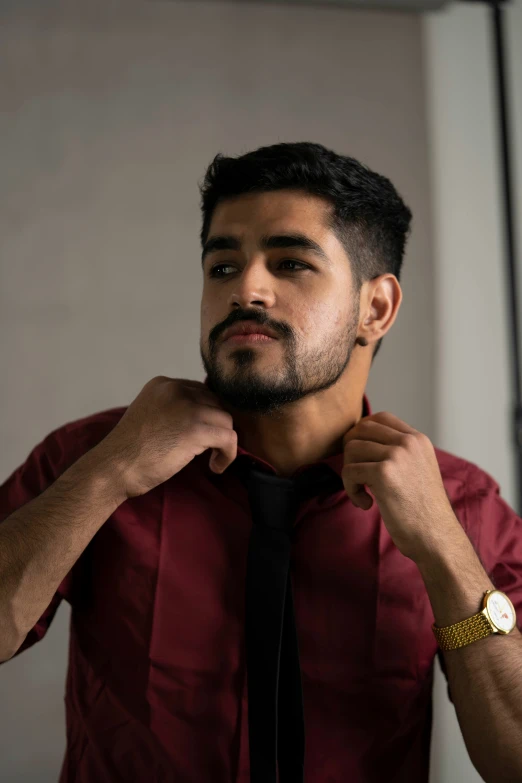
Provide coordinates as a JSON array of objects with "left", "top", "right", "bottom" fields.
[{"left": 342, "top": 412, "right": 463, "bottom": 561}]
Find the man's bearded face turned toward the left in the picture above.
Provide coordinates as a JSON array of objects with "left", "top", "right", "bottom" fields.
[{"left": 200, "top": 190, "right": 359, "bottom": 415}]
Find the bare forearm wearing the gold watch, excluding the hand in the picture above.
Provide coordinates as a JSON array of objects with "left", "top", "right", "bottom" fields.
[{"left": 417, "top": 527, "right": 522, "bottom": 783}]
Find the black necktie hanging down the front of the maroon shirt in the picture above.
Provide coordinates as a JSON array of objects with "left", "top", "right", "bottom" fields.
[{"left": 233, "top": 458, "right": 344, "bottom": 783}]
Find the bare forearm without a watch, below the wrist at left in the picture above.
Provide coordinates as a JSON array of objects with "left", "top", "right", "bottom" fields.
[{"left": 0, "top": 448, "right": 125, "bottom": 660}]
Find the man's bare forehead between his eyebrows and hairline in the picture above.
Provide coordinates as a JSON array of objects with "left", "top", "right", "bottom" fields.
[{"left": 209, "top": 190, "right": 331, "bottom": 238}]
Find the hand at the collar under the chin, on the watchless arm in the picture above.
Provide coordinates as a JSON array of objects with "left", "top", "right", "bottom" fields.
[{"left": 96, "top": 375, "right": 237, "bottom": 498}]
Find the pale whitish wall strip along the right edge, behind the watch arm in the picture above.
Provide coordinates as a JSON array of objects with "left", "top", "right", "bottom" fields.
[{"left": 423, "top": 0, "right": 522, "bottom": 783}]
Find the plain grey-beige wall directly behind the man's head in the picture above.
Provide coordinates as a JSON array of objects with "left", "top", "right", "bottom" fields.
[{"left": 0, "top": 0, "right": 435, "bottom": 783}]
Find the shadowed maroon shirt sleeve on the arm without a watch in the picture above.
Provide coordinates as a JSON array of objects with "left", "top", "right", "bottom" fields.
[{"left": 0, "top": 430, "right": 78, "bottom": 657}]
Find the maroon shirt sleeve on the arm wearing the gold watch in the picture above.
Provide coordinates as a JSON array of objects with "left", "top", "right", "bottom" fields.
[{"left": 437, "top": 464, "right": 522, "bottom": 702}]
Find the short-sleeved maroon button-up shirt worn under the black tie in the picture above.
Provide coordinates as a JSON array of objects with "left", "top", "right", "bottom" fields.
[{"left": 0, "top": 396, "right": 522, "bottom": 783}]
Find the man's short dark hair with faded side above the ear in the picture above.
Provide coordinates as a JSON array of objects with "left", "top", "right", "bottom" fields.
[{"left": 199, "top": 141, "right": 412, "bottom": 361}]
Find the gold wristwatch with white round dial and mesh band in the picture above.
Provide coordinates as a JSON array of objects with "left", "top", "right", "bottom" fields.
[{"left": 431, "top": 590, "right": 517, "bottom": 650}]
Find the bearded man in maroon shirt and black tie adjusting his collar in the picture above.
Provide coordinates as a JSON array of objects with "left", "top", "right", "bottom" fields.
[{"left": 0, "top": 143, "right": 522, "bottom": 783}]
